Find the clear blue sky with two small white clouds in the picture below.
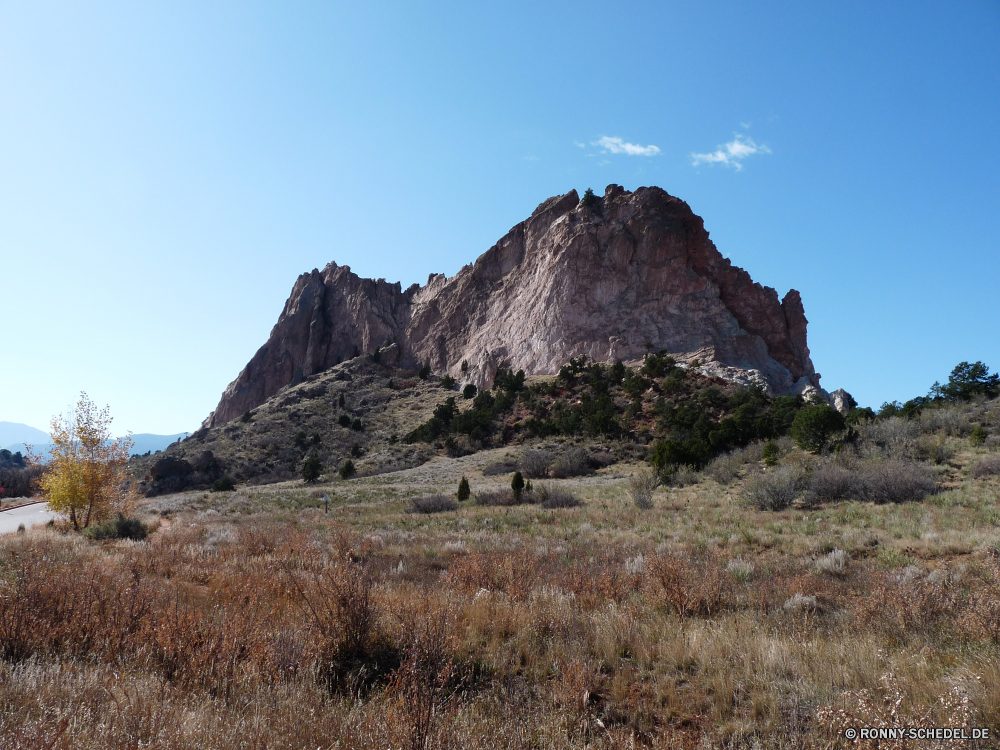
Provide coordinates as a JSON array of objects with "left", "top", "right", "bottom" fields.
[{"left": 0, "top": 0, "right": 1000, "bottom": 433}]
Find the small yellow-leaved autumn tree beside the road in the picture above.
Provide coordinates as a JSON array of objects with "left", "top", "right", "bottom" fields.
[{"left": 41, "top": 393, "right": 135, "bottom": 529}]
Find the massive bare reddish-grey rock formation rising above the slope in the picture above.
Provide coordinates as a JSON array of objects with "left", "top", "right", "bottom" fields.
[{"left": 206, "top": 185, "right": 819, "bottom": 427}]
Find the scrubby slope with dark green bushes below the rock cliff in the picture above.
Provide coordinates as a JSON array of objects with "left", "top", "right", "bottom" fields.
[{"left": 133, "top": 346, "right": 848, "bottom": 494}]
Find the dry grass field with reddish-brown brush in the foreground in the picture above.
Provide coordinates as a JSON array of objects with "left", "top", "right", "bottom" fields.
[{"left": 0, "top": 402, "right": 1000, "bottom": 748}]
